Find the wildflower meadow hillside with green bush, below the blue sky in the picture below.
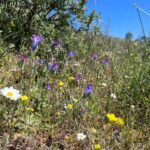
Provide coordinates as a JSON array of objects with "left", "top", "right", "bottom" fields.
[{"left": 0, "top": 0, "right": 150, "bottom": 150}]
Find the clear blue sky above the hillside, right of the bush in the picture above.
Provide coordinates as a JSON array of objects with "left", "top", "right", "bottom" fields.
[{"left": 86, "top": 0, "right": 150, "bottom": 38}]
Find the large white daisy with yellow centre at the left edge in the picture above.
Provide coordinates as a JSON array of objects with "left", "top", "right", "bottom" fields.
[{"left": 0, "top": 86, "right": 21, "bottom": 101}]
